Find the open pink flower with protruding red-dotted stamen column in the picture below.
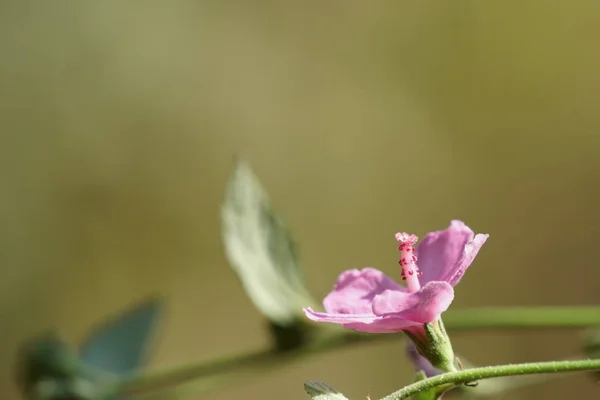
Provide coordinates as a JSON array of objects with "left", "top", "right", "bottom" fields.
[{"left": 304, "top": 221, "right": 488, "bottom": 336}]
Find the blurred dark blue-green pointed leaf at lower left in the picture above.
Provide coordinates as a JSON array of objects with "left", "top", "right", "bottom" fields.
[{"left": 80, "top": 299, "right": 161, "bottom": 376}]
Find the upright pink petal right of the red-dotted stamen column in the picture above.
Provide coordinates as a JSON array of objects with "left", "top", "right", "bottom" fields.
[{"left": 417, "top": 220, "right": 487, "bottom": 286}]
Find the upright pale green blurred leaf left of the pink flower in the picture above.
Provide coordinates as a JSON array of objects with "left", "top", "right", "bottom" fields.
[{"left": 221, "top": 161, "right": 312, "bottom": 327}]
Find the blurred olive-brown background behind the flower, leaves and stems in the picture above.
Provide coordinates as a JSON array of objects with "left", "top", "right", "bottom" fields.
[{"left": 0, "top": 0, "right": 600, "bottom": 400}]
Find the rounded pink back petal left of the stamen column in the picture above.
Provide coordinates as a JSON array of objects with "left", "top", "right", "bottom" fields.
[{"left": 323, "top": 268, "right": 406, "bottom": 315}]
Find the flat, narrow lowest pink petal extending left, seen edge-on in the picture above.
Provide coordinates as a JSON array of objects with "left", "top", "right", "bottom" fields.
[{"left": 303, "top": 308, "right": 418, "bottom": 333}]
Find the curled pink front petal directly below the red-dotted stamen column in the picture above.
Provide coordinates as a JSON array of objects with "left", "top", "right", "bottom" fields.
[{"left": 373, "top": 282, "right": 454, "bottom": 323}]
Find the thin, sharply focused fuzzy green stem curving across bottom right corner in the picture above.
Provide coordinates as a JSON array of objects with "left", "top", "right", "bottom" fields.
[{"left": 381, "top": 360, "right": 600, "bottom": 400}]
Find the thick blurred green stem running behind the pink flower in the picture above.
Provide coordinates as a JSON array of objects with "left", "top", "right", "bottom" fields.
[{"left": 123, "top": 307, "right": 600, "bottom": 393}]
